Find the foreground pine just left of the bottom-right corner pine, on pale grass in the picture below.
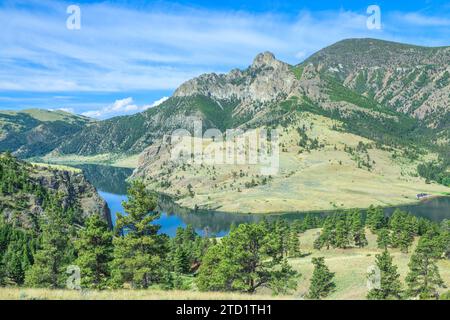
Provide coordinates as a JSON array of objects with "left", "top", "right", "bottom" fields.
[{"left": 367, "top": 250, "right": 401, "bottom": 300}]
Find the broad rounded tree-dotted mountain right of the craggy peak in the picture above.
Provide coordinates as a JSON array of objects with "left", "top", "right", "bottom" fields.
[{"left": 303, "top": 39, "right": 450, "bottom": 137}]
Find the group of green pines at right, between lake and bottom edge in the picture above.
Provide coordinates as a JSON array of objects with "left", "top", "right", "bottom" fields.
[{"left": 314, "top": 206, "right": 450, "bottom": 300}]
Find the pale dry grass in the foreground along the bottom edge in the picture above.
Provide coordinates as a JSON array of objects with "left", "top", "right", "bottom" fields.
[{"left": 0, "top": 230, "right": 450, "bottom": 300}]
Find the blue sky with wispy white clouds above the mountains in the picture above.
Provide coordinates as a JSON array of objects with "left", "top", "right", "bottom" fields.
[{"left": 0, "top": 0, "right": 450, "bottom": 119}]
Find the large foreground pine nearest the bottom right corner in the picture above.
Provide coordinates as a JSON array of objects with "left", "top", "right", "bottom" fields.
[{"left": 406, "top": 234, "right": 444, "bottom": 299}]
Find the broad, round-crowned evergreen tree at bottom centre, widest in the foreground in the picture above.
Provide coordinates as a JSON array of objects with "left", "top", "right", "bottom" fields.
[{"left": 196, "top": 222, "right": 297, "bottom": 293}]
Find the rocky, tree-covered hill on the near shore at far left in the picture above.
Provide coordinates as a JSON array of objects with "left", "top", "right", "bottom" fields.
[{"left": 0, "top": 153, "right": 112, "bottom": 230}]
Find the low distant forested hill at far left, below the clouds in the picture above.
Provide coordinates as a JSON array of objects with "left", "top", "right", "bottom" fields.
[{"left": 0, "top": 109, "right": 93, "bottom": 158}]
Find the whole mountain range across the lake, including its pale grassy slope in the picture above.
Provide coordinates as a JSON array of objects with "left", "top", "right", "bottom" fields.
[{"left": 0, "top": 39, "right": 450, "bottom": 212}]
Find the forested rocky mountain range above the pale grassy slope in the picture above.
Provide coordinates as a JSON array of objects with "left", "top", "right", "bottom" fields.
[{"left": 0, "top": 39, "right": 450, "bottom": 157}]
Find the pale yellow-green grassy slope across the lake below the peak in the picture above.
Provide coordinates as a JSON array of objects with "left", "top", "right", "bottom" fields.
[{"left": 141, "top": 113, "right": 450, "bottom": 213}]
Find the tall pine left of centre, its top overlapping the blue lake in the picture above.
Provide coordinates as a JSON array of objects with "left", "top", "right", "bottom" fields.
[{"left": 112, "top": 181, "right": 168, "bottom": 288}]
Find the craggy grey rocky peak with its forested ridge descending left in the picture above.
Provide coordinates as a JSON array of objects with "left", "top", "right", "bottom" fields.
[{"left": 58, "top": 53, "right": 297, "bottom": 155}]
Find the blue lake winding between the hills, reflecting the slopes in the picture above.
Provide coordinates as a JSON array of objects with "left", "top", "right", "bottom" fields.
[{"left": 77, "top": 165, "right": 450, "bottom": 236}]
